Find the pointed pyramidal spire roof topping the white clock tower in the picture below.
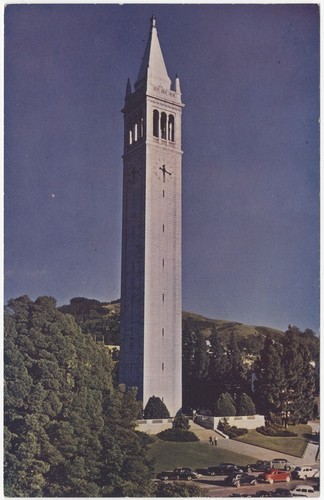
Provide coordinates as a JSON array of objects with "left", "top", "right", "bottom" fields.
[{"left": 135, "top": 16, "right": 171, "bottom": 88}]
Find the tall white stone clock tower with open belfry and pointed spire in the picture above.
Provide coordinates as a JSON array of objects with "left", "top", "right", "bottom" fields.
[{"left": 119, "top": 17, "right": 183, "bottom": 416}]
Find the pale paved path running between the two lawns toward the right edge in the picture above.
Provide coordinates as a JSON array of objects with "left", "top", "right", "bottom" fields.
[{"left": 190, "top": 422, "right": 319, "bottom": 465}]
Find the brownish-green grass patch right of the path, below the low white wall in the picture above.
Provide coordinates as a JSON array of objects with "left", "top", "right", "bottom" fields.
[{"left": 233, "top": 424, "right": 312, "bottom": 457}]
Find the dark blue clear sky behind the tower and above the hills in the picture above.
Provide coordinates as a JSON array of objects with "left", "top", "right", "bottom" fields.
[{"left": 5, "top": 4, "right": 319, "bottom": 331}]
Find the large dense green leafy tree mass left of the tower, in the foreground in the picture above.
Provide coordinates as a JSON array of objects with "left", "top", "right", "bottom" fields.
[{"left": 4, "top": 296, "right": 152, "bottom": 497}]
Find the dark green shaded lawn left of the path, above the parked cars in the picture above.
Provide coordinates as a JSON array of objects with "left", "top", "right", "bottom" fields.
[{"left": 148, "top": 438, "right": 256, "bottom": 472}]
